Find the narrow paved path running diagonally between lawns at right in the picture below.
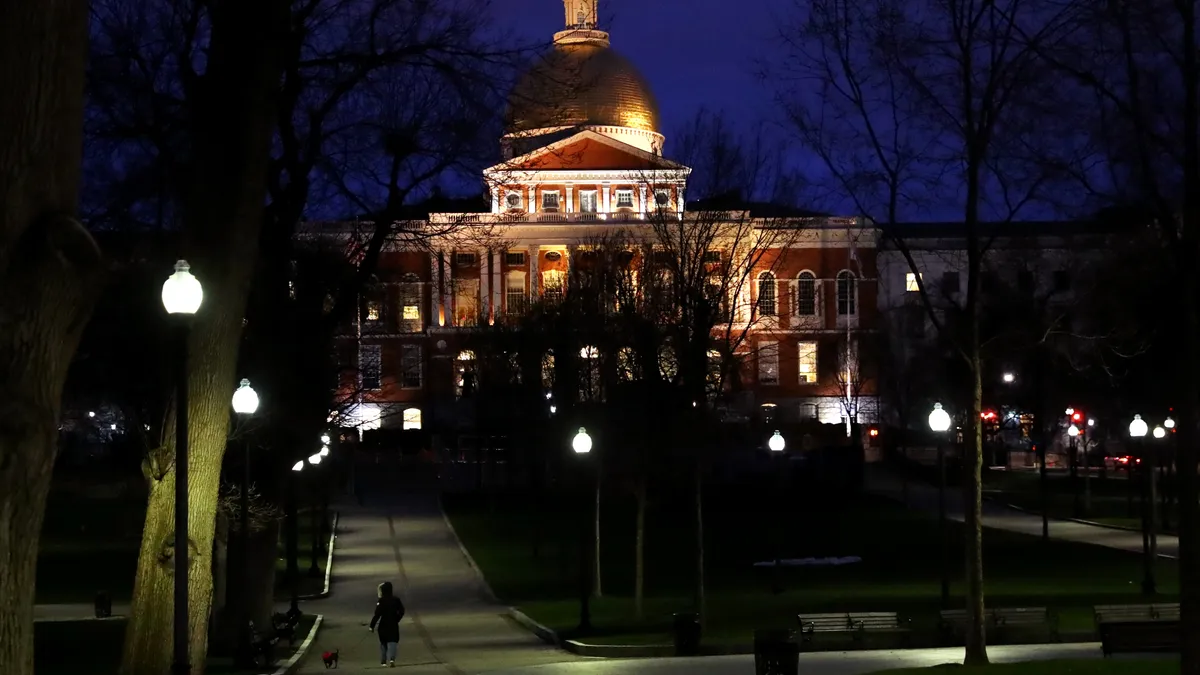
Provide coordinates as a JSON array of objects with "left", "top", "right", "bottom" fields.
[{"left": 866, "top": 465, "right": 1180, "bottom": 558}]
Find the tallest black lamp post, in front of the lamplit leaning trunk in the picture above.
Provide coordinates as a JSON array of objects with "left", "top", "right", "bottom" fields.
[{"left": 162, "top": 261, "right": 204, "bottom": 675}]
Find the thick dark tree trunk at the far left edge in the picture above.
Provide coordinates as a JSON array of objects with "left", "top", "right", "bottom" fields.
[{"left": 0, "top": 0, "right": 101, "bottom": 675}]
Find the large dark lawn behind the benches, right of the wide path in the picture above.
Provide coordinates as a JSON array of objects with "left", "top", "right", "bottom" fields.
[{"left": 445, "top": 480, "right": 1177, "bottom": 644}]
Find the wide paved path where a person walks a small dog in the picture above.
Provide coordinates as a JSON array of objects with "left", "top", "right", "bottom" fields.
[{"left": 300, "top": 464, "right": 578, "bottom": 675}]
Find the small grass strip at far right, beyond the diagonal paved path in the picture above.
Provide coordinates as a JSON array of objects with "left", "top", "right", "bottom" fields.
[{"left": 984, "top": 471, "right": 1176, "bottom": 532}]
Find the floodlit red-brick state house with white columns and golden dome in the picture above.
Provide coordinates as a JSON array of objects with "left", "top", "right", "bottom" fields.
[{"left": 322, "top": 0, "right": 876, "bottom": 437}]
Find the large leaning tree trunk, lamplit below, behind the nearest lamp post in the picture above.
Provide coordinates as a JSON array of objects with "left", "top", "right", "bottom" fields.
[{"left": 121, "top": 5, "right": 290, "bottom": 675}]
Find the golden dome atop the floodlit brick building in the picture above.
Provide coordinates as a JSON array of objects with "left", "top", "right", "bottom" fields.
[{"left": 508, "top": 42, "right": 660, "bottom": 133}]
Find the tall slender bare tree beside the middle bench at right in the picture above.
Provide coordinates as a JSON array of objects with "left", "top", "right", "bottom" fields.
[{"left": 776, "top": 0, "right": 1070, "bottom": 664}]
